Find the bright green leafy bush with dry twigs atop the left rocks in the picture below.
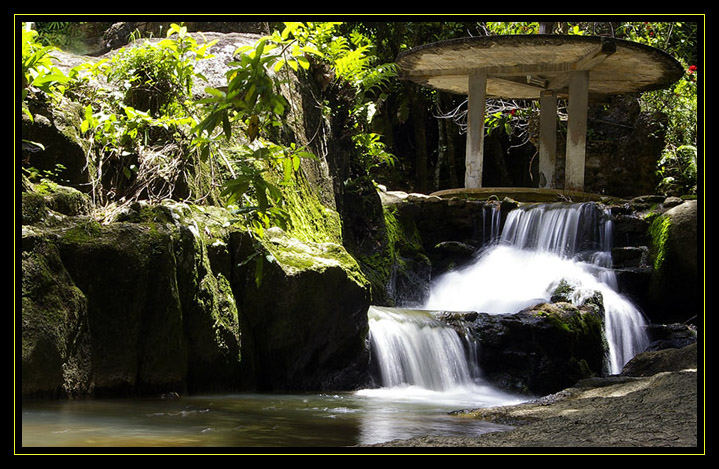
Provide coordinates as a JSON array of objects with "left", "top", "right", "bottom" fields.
[{"left": 68, "top": 24, "right": 213, "bottom": 202}]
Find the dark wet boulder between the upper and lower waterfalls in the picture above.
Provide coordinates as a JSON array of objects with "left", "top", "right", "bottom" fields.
[{"left": 444, "top": 289, "right": 608, "bottom": 395}]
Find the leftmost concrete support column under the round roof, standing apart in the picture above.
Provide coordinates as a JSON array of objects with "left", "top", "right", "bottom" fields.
[{"left": 464, "top": 72, "right": 487, "bottom": 189}]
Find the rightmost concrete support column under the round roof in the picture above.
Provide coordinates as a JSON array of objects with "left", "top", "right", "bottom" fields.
[{"left": 564, "top": 70, "right": 589, "bottom": 191}]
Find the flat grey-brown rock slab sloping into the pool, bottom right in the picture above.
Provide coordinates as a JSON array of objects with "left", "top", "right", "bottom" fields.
[{"left": 366, "top": 344, "right": 704, "bottom": 453}]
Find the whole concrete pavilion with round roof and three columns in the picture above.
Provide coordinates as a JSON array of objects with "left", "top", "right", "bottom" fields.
[{"left": 397, "top": 34, "right": 684, "bottom": 196}]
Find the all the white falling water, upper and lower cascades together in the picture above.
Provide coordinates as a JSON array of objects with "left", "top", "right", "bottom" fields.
[{"left": 357, "top": 204, "right": 648, "bottom": 407}]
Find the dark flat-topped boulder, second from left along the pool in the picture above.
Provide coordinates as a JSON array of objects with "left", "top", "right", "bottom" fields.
[{"left": 52, "top": 221, "right": 186, "bottom": 396}]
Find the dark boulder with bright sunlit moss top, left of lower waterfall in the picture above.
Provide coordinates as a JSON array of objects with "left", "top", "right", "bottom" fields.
[{"left": 233, "top": 228, "right": 370, "bottom": 391}]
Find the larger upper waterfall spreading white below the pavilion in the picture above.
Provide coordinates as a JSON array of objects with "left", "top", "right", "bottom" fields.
[{"left": 424, "top": 203, "right": 648, "bottom": 374}]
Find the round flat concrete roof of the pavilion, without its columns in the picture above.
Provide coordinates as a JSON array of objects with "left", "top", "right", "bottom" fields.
[{"left": 397, "top": 34, "right": 684, "bottom": 99}]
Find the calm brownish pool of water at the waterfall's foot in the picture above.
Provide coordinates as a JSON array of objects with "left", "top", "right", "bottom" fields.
[{"left": 21, "top": 388, "right": 522, "bottom": 447}]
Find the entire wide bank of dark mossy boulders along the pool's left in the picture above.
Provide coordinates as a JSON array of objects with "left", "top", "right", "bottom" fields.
[{"left": 22, "top": 192, "right": 376, "bottom": 396}]
